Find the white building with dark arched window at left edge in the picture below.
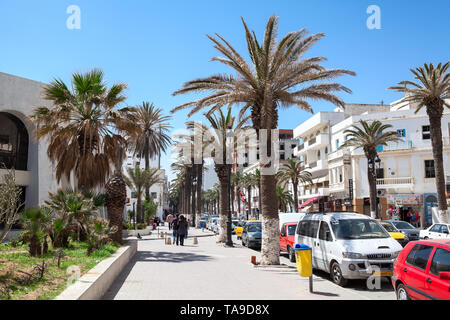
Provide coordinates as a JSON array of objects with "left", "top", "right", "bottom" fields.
[{"left": 0, "top": 72, "right": 58, "bottom": 207}]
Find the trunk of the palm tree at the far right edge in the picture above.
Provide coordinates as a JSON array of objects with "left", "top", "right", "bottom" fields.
[{"left": 428, "top": 114, "right": 449, "bottom": 227}]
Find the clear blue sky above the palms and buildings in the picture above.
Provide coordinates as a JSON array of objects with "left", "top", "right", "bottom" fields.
[{"left": 0, "top": 0, "right": 450, "bottom": 181}]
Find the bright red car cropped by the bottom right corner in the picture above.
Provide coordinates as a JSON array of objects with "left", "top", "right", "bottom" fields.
[{"left": 392, "top": 239, "right": 450, "bottom": 300}]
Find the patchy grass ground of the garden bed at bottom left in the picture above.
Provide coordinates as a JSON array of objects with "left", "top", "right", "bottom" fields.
[{"left": 0, "top": 242, "right": 119, "bottom": 300}]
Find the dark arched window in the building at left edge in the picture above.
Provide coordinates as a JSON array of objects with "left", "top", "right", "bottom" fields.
[{"left": 0, "top": 112, "right": 28, "bottom": 171}]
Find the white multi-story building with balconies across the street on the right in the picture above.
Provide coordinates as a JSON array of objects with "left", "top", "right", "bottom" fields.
[{"left": 294, "top": 100, "right": 450, "bottom": 224}]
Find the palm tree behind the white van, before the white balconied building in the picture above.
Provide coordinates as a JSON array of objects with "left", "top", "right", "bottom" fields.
[{"left": 341, "top": 120, "right": 402, "bottom": 219}]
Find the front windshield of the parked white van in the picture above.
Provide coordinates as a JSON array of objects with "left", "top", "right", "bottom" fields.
[{"left": 331, "top": 219, "right": 390, "bottom": 240}]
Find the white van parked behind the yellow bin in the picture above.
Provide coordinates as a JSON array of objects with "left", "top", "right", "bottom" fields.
[{"left": 295, "top": 212, "right": 403, "bottom": 286}]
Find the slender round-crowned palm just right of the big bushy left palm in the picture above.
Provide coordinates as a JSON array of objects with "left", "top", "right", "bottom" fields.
[{"left": 131, "top": 102, "right": 172, "bottom": 201}]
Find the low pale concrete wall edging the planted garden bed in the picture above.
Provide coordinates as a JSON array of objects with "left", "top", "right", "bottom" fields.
[{"left": 54, "top": 240, "right": 137, "bottom": 300}]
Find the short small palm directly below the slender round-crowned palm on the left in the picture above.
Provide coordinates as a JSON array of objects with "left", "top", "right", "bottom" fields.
[{"left": 124, "top": 165, "right": 161, "bottom": 223}]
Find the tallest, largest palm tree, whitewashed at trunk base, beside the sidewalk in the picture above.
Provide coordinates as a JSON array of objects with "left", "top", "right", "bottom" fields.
[{"left": 172, "top": 16, "right": 354, "bottom": 265}]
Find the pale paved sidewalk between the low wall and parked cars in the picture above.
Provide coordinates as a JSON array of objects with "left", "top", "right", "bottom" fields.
[{"left": 104, "top": 228, "right": 384, "bottom": 300}]
